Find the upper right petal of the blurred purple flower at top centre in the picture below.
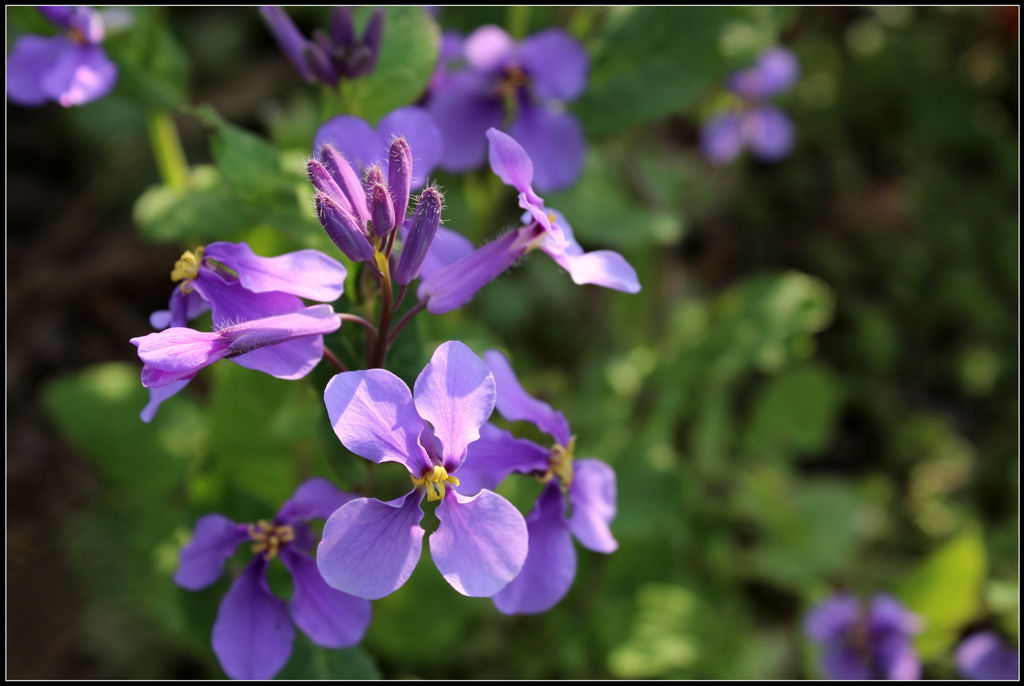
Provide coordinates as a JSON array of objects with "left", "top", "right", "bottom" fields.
[{"left": 519, "top": 29, "right": 589, "bottom": 102}]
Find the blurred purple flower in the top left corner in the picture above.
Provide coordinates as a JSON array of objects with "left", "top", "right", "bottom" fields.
[{"left": 7, "top": 6, "right": 118, "bottom": 108}]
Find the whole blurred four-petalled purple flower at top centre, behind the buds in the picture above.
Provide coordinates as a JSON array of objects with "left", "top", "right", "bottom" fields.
[{"left": 427, "top": 25, "right": 589, "bottom": 190}]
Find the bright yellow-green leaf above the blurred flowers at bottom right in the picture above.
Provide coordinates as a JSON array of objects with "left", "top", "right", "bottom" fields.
[{"left": 897, "top": 526, "right": 987, "bottom": 659}]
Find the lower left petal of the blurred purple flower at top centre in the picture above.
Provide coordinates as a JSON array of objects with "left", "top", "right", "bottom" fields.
[{"left": 427, "top": 72, "right": 505, "bottom": 172}]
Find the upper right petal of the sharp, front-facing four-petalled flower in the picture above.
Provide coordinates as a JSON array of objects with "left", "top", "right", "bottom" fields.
[{"left": 413, "top": 341, "right": 495, "bottom": 472}]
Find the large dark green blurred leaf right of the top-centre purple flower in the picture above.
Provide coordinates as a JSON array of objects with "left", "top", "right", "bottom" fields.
[{"left": 573, "top": 7, "right": 735, "bottom": 136}]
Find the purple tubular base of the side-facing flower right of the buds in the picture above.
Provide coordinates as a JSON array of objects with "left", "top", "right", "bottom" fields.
[{"left": 417, "top": 226, "right": 543, "bottom": 314}]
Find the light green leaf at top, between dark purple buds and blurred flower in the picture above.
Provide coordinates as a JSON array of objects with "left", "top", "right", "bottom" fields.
[{"left": 342, "top": 7, "right": 440, "bottom": 124}]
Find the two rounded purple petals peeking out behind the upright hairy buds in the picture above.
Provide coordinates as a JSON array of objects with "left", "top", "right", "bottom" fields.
[{"left": 313, "top": 105, "right": 441, "bottom": 188}]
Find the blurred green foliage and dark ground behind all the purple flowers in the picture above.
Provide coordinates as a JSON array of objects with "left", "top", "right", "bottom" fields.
[{"left": 6, "top": 7, "right": 1019, "bottom": 679}]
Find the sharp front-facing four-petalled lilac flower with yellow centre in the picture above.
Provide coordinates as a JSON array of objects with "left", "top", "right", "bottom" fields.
[{"left": 316, "top": 341, "right": 526, "bottom": 599}]
